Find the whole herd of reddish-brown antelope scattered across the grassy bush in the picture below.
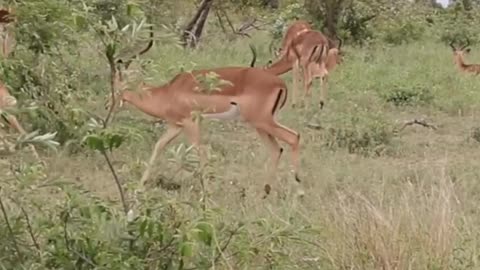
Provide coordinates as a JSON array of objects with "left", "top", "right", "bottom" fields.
[{"left": 0, "top": 9, "right": 480, "bottom": 196}]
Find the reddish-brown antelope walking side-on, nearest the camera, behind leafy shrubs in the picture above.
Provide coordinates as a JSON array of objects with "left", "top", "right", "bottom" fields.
[{"left": 119, "top": 67, "right": 303, "bottom": 197}]
